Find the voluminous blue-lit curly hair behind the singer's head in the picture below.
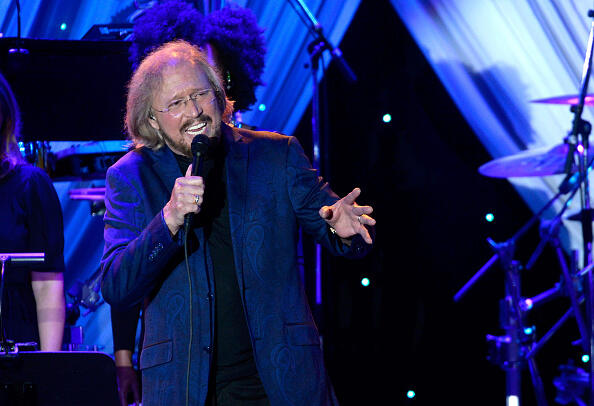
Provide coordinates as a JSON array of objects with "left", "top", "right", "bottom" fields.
[{"left": 130, "top": 0, "right": 266, "bottom": 111}]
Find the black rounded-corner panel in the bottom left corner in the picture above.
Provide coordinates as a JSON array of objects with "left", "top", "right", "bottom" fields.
[{"left": 0, "top": 351, "right": 119, "bottom": 406}]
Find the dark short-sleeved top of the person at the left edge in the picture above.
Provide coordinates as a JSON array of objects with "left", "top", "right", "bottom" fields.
[{"left": 0, "top": 165, "right": 64, "bottom": 342}]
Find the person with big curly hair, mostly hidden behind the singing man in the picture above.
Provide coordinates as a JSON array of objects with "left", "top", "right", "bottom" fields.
[{"left": 111, "top": 0, "right": 266, "bottom": 406}]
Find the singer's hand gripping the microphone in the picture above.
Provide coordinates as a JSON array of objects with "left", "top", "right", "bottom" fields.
[{"left": 163, "top": 165, "right": 204, "bottom": 235}]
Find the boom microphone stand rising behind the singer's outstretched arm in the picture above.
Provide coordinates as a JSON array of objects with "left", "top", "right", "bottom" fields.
[{"left": 288, "top": 0, "right": 357, "bottom": 314}]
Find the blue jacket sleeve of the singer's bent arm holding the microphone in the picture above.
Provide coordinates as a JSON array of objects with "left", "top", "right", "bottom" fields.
[{"left": 101, "top": 163, "right": 179, "bottom": 307}]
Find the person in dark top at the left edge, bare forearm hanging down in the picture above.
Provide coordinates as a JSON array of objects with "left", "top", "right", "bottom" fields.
[{"left": 0, "top": 75, "right": 65, "bottom": 351}]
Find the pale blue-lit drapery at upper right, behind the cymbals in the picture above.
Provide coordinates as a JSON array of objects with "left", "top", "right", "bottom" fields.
[{"left": 392, "top": 0, "right": 593, "bottom": 256}]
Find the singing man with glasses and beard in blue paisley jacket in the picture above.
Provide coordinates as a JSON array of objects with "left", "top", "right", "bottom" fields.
[{"left": 101, "top": 41, "right": 375, "bottom": 406}]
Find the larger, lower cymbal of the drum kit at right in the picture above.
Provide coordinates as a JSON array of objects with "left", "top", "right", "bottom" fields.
[{"left": 479, "top": 144, "right": 594, "bottom": 178}]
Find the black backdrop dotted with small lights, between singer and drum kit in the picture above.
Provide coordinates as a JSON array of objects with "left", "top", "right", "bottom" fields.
[{"left": 295, "top": 0, "right": 587, "bottom": 405}]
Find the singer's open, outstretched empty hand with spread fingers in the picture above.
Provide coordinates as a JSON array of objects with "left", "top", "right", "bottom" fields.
[{"left": 319, "top": 188, "right": 375, "bottom": 244}]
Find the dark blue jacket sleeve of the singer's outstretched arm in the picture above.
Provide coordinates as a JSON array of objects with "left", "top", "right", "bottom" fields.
[{"left": 287, "top": 137, "right": 374, "bottom": 258}]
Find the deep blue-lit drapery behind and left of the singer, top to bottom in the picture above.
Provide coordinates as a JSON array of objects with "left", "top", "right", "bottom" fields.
[{"left": 0, "top": 0, "right": 360, "bottom": 352}]
